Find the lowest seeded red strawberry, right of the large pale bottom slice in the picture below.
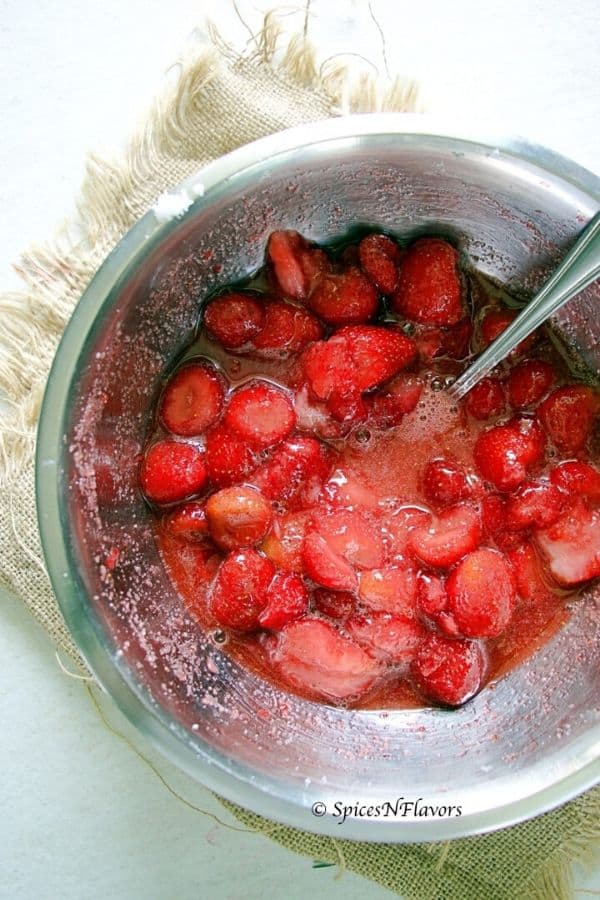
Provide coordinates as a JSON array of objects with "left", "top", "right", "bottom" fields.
[{"left": 411, "top": 634, "right": 486, "bottom": 706}]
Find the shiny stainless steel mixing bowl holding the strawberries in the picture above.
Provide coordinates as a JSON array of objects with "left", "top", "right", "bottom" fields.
[{"left": 37, "top": 116, "right": 600, "bottom": 842}]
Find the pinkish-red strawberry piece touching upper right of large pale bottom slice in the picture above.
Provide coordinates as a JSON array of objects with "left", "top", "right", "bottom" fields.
[{"left": 344, "top": 612, "right": 426, "bottom": 664}]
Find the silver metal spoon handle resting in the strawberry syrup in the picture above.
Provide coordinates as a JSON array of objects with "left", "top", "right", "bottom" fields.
[{"left": 448, "top": 212, "right": 600, "bottom": 400}]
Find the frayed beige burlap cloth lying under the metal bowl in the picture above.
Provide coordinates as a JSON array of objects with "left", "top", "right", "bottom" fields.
[{"left": 0, "top": 19, "right": 600, "bottom": 900}]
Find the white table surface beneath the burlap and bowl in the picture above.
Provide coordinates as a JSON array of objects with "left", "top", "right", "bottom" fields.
[{"left": 0, "top": 0, "right": 600, "bottom": 900}]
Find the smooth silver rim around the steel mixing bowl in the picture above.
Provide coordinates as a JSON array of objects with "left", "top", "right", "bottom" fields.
[{"left": 35, "top": 113, "right": 600, "bottom": 843}]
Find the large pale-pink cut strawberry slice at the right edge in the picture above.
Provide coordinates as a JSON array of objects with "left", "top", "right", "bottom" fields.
[{"left": 535, "top": 498, "right": 600, "bottom": 587}]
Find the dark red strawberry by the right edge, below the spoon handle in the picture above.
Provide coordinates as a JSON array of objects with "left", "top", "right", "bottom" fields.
[{"left": 537, "top": 384, "right": 600, "bottom": 453}]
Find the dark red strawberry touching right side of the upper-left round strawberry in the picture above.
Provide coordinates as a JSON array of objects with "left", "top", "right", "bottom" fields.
[{"left": 252, "top": 300, "right": 323, "bottom": 359}]
